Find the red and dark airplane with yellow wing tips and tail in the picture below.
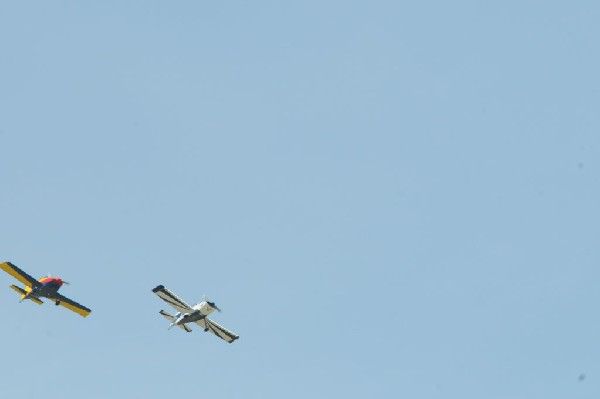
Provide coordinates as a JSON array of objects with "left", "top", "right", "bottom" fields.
[{"left": 0, "top": 262, "right": 92, "bottom": 317}]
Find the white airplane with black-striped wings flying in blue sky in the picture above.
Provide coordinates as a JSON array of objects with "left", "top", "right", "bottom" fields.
[{"left": 152, "top": 285, "right": 239, "bottom": 343}]
